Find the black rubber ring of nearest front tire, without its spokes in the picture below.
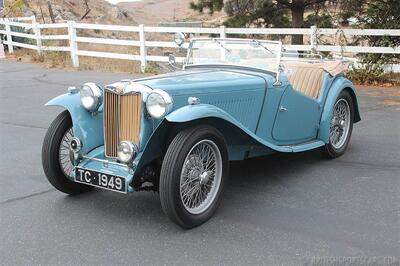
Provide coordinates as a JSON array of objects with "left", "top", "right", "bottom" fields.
[{"left": 160, "top": 125, "right": 229, "bottom": 229}]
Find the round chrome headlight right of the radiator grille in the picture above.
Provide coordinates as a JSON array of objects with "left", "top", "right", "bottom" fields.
[{"left": 146, "top": 89, "right": 172, "bottom": 119}]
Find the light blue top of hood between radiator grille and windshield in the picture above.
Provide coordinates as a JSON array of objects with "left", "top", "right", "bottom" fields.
[{"left": 134, "top": 69, "right": 268, "bottom": 95}]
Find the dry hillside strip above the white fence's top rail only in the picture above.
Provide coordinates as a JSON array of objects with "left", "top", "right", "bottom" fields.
[{"left": 1, "top": 0, "right": 225, "bottom": 25}]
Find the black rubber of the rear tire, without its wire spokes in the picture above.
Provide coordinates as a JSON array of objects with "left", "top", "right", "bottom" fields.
[{"left": 321, "top": 90, "right": 354, "bottom": 159}]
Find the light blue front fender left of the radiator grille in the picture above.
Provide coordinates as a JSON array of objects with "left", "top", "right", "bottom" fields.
[{"left": 45, "top": 93, "right": 104, "bottom": 154}]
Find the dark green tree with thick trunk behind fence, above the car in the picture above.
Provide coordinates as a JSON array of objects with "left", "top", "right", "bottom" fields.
[{"left": 190, "top": 0, "right": 335, "bottom": 44}]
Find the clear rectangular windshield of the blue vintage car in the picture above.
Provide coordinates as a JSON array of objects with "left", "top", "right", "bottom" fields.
[{"left": 186, "top": 39, "right": 282, "bottom": 72}]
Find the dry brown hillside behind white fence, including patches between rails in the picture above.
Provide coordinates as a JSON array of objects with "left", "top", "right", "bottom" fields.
[{"left": 0, "top": 0, "right": 224, "bottom": 72}]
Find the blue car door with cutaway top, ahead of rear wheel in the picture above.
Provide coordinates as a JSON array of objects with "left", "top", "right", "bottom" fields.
[{"left": 272, "top": 85, "right": 321, "bottom": 145}]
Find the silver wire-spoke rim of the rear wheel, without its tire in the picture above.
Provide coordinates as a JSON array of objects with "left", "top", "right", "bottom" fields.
[{"left": 329, "top": 98, "right": 351, "bottom": 149}]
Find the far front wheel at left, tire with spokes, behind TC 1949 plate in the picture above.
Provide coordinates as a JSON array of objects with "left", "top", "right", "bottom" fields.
[{"left": 42, "top": 111, "right": 93, "bottom": 195}]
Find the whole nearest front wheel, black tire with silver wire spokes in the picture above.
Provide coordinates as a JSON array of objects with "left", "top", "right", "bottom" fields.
[{"left": 160, "top": 126, "right": 229, "bottom": 229}]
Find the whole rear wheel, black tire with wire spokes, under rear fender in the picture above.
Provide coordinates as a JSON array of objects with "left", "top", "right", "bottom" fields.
[{"left": 321, "top": 90, "right": 354, "bottom": 159}]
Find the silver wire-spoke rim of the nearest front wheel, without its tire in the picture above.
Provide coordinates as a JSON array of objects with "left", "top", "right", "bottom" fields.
[{"left": 180, "top": 139, "right": 222, "bottom": 214}]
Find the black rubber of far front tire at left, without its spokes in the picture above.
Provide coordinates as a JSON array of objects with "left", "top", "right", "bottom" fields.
[{"left": 42, "top": 111, "right": 93, "bottom": 195}]
